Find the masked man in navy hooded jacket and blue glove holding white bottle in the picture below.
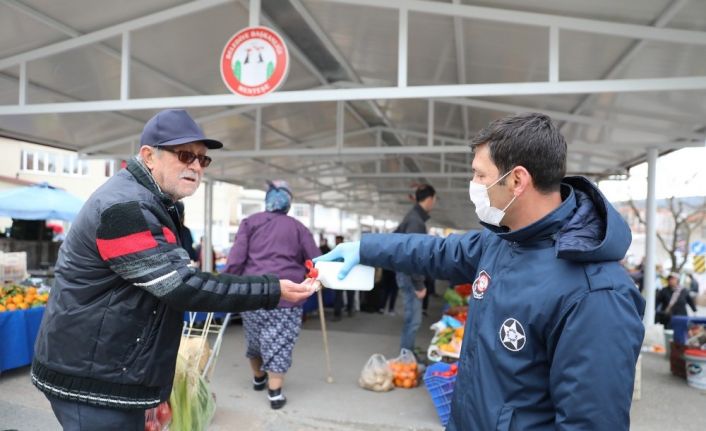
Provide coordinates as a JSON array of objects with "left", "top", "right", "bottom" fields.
[{"left": 317, "top": 113, "right": 645, "bottom": 431}]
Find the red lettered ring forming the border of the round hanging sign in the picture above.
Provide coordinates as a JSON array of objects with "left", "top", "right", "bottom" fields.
[{"left": 220, "top": 27, "right": 289, "bottom": 97}]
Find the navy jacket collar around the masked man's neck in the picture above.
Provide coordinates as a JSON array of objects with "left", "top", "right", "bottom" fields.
[{"left": 481, "top": 183, "right": 576, "bottom": 243}]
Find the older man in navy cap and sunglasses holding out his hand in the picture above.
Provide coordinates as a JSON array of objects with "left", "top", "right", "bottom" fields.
[{"left": 31, "top": 110, "right": 314, "bottom": 431}]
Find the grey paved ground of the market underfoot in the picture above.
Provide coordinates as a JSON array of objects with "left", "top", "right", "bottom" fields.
[{"left": 0, "top": 299, "right": 706, "bottom": 431}]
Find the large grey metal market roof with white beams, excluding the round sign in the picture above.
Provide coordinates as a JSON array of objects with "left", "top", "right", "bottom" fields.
[{"left": 0, "top": 0, "right": 706, "bottom": 229}]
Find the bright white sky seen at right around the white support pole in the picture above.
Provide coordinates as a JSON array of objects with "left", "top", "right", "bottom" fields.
[{"left": 599, "top": 147, "right": 706, "bottom": 202}]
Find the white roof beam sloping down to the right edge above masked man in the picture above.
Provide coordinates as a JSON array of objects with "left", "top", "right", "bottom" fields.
[{"left": 318, "top": 0, "right": 706, "bottom": 45}]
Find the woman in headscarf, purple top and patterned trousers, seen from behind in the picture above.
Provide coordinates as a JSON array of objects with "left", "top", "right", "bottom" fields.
[{"left": 224, "top": 181, "right": 320, "bottom": 409}]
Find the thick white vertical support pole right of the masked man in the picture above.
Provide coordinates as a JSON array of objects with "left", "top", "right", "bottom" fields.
[{"left": 642, "top": 148, "right": 657, "bottom": 327}]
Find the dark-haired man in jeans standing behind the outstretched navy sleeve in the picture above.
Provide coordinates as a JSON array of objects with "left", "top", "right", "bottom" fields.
[{"left": 395, "top": 184, "right": 436, "bottom": 351}]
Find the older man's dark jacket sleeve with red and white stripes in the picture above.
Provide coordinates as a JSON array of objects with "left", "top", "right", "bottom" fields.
[{"left": 96, "top": 202, "right": 280, "bottom": 312}]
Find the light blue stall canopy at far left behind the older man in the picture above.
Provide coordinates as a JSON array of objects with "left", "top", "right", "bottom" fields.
[{"left": 0, "top": 183, "right": 83, "bottom": 221}]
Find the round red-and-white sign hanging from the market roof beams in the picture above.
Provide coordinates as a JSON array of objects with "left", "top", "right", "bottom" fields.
[{"left": 221, "top": 27, "right": 289, "bottom": 97}]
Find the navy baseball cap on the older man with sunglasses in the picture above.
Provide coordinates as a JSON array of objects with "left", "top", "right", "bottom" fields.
[{"left": 140, "top": 109, "right": 223, "bottom": 150}]
